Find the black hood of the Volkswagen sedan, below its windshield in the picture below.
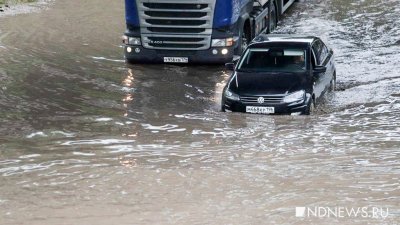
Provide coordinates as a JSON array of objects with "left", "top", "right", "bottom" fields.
[{"left": 230, "top": 72, "right": 307, "bottom": 95}]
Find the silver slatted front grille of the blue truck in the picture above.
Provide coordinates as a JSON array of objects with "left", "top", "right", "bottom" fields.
[{"left": 136, "top": 0, "right": 216, "bottom": 50}]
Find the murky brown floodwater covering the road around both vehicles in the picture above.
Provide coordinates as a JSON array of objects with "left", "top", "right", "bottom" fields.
[{"left": 0, "top": 0, "right": 400, "bottom": 225}]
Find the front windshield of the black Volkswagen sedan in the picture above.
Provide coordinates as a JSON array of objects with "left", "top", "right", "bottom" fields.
[{"left": 238, "top": 48, "right": 306, "bottom": 72}]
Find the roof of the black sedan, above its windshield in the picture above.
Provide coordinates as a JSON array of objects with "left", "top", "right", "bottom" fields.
[{"left": 250, "top": 34, "right": 318, "bottom": 47}]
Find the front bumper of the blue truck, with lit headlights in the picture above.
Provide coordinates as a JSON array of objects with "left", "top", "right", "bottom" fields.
[{"left": 124, "top": 45, "right": 234, "bottom": 64}]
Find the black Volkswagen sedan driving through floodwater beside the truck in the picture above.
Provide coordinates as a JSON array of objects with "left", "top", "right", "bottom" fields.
[{"left": 221, "top": 35, "right": 336, "bottom": 115}]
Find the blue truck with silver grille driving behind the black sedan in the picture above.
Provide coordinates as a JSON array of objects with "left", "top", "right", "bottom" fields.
[{"left": 123, "top": 0, "right": 294, "bottom": 63}]
